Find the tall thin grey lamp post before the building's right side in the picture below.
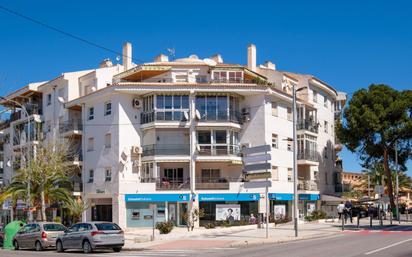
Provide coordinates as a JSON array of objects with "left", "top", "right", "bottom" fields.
[{"left": 292, "top": 84, "right": 299, "bottom": 237}]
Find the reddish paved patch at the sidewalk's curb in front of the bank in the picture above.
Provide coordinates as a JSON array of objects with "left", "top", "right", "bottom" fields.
[{"left": 148, "top": 240, "right": 234, "bottom": 250}]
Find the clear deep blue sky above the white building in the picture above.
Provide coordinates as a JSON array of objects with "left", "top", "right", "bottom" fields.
[{"left": 0, "top": 0, "right": 412, "bottom": 174}]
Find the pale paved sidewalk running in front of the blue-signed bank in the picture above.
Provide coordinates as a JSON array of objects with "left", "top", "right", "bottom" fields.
[{"left": 124, "top": 218, "right": 412, "bottom": 250}]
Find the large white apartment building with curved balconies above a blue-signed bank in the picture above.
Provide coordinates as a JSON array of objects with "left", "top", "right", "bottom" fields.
[{"left": 3, "top": 44, "right": 346, "bottom": 228}]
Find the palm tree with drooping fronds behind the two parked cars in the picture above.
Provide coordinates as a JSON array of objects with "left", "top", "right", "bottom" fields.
[{"left": 0, "top": 142, "right": 71, "bottom": 221}]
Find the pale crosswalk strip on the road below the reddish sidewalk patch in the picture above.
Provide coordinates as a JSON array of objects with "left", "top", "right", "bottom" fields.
[{"left": 85, "top": 248, "right": 235, "bottom": 257}]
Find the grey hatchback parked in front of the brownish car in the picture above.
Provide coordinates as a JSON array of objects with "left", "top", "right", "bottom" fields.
[{"left": 56, "top": 221, "right": 124, "bottom": 253}]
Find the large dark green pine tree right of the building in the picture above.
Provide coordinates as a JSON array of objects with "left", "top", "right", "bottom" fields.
[{"left": 336, "top": 84, "right": 412, "bottom": 208}]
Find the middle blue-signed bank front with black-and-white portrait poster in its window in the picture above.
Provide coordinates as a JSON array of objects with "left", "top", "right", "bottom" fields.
[{"left": 198, "top": 193, "right": 260, "bottom": 226}]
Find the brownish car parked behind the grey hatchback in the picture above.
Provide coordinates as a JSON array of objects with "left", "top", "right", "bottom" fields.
[{"left": 13, "top": 222, "right": 66, "bottom": 251}]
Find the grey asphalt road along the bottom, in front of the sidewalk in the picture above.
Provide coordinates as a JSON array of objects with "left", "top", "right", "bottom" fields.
[{"left": 0, "top": 227, "right": 412, "bottom": 257}]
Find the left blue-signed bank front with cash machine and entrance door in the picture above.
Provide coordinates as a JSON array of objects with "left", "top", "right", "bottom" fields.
[{"left": 125, "top": 194, "right": 190, "bottom": 227}]
